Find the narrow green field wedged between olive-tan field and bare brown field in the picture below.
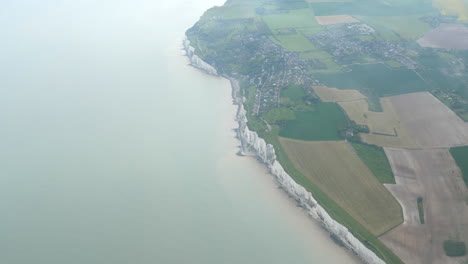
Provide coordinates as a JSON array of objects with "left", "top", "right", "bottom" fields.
[{"left": 351, "top": 142, "right": 395, "bottom": 184}]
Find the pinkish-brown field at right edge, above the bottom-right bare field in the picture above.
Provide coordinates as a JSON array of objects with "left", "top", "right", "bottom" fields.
[{"left": 388, "top": 92, "right": 468, "bottom": 148}]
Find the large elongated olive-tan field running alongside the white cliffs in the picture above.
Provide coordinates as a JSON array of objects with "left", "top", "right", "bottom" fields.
[{"left": 280, "top": 138, "right": 403, "bottom": 235}]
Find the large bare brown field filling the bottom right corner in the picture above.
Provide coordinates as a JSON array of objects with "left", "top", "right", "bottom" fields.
[{"left": 381, "top": 148, "right": 468, "bottom": 264}]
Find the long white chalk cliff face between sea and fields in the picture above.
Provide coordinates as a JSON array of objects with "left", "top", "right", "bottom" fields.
[{"left": 183, "top": 39, "right": 385, "bottom": 264}]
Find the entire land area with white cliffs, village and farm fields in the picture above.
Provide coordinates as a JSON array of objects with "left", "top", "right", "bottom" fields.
[{"left": 184, "top": 0, "right": 468, "bottom": 264}]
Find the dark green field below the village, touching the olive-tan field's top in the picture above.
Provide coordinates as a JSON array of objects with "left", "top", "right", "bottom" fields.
[{"left": 279, "top": 103, "right": 348, "bottom": 140}]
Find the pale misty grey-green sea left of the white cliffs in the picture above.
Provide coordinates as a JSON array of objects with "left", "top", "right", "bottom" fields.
[{"left": 0, "top": 0, "right": 356, "bottom": 264}]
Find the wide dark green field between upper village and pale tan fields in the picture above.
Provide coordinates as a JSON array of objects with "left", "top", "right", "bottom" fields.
[{"left": 316, "top": 63, "right": 429, "bottom": 99}]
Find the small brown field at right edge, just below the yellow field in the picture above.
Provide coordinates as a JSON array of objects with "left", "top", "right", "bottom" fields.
[{"left": 418, "top": 24, "right": 468, "bottom": 50}]
